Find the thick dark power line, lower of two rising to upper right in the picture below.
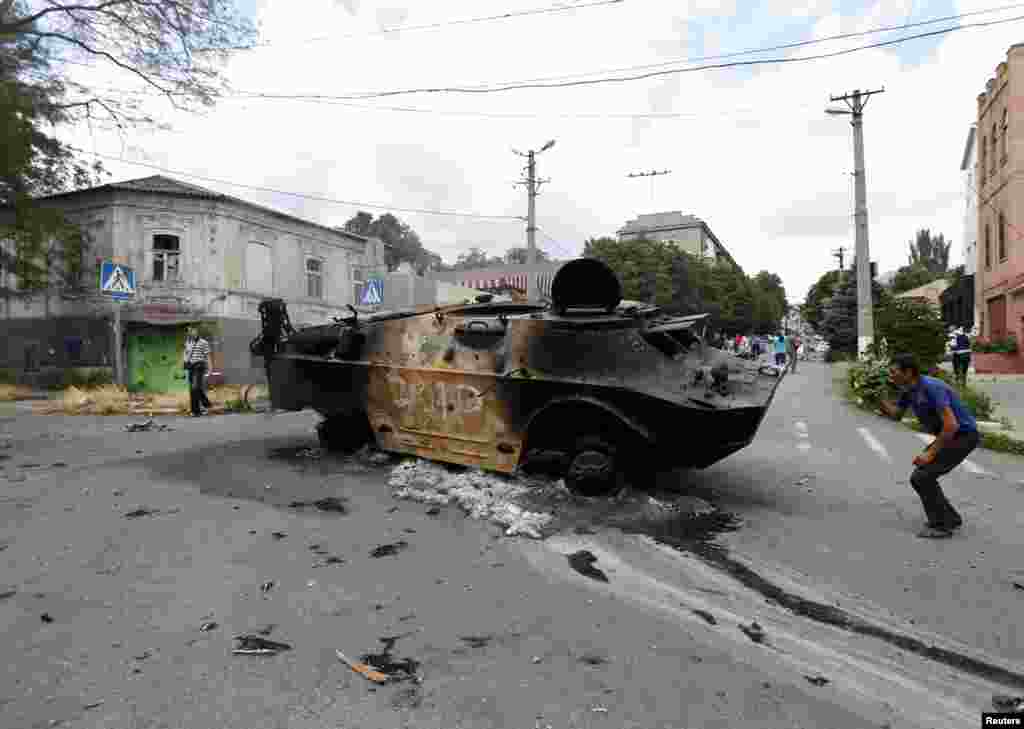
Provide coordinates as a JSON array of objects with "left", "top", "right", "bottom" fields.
[{"left": 228, "top": 7, "right": 1024, "bottom": 100}]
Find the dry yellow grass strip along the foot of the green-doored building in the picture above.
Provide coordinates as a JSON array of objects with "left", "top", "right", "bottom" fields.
[{"left": 36, "top": 385, "right": 262, "bottom": 416}]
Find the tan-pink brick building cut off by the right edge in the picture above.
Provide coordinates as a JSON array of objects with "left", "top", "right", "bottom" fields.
[{"left": 975, "top": 43, "right": 1024, "bottom": 348}]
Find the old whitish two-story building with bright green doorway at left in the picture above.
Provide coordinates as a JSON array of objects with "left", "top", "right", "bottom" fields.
[{"left": 0, "top": 175, "right": 387, "bottom": 391}]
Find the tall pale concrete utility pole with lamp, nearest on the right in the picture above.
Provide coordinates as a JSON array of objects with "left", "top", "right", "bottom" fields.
[{"left": 825, "top": 88, "right": 885, "bottom": 354}]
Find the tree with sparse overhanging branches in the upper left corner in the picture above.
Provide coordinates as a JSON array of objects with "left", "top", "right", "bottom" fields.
[{"left": 0, "top": 0, "right": 256, "bottom": 295}]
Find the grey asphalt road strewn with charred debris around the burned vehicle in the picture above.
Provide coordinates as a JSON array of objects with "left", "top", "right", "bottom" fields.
[{"left": 0, "top": 362, "right": 1024, "bottom": 729}]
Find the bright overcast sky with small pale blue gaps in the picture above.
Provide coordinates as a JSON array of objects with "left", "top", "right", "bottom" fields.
[{"left": 58, "top": 0, "right": 1024, "bottom": 302}]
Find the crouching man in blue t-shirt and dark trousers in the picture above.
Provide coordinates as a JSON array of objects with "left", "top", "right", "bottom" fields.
[{"left": 881, "top": 354, "right": 981, "bottom": 539}]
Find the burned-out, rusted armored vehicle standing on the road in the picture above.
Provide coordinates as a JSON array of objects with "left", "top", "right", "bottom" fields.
[{"left": 251, "top": 259, "right": 782, "bottom": 495}]
